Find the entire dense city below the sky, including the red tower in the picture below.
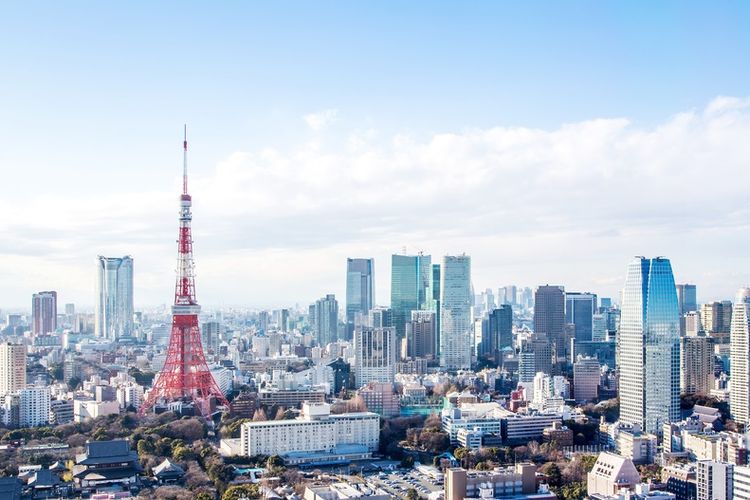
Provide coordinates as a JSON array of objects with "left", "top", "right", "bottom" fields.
[{"left": 0, "top": 132, "right": 750, "bottom": 500}]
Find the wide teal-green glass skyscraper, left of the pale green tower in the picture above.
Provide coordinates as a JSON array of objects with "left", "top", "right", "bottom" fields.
[{"left": 391, "top": 253, "right": 432, "bottom": 339}]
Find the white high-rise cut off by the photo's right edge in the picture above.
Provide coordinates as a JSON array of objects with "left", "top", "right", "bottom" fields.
[{"left": 729, "top": 288, "right": 750, "bottom": 428}]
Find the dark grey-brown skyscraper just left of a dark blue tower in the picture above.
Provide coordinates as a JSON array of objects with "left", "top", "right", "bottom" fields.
[{"left": 534, "top": 285, "right": 569, "bottom": 365}]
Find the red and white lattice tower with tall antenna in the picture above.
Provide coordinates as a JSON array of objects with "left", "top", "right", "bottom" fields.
[{"left": 140, "top": 127, "right": 229, "bottom": 417}]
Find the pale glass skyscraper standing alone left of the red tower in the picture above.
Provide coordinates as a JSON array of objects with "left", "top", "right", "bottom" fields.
[{"left": 94, "top": 255, "right": 133, "bottom": 340}]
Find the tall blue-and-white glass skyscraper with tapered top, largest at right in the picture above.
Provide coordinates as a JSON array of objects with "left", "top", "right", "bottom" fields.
[{"left": 620, "top": 257, "right": 680, "bottom": 434}]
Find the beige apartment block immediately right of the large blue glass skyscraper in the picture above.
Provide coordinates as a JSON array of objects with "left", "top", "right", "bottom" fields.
[{"left": 680, "top": 335, "right": 714, "bottom": 395}]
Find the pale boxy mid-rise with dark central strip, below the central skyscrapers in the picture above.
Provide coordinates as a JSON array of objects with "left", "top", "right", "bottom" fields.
[{"left": 354, "top": 326, "right": 397, "bottom": 387}]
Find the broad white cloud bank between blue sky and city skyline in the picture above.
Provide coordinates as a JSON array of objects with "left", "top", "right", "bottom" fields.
[{"left": 0, "top": 97, "right": 750, "bottom": 307}]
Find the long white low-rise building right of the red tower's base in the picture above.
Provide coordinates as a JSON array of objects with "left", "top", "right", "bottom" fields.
[{"left": 240, "top": 403, "right": 380, "bottom": 463}]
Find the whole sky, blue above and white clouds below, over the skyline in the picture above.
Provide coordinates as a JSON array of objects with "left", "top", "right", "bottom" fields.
[{"left": 0, "top": 2, "right": 750, "bottom": 309}]
